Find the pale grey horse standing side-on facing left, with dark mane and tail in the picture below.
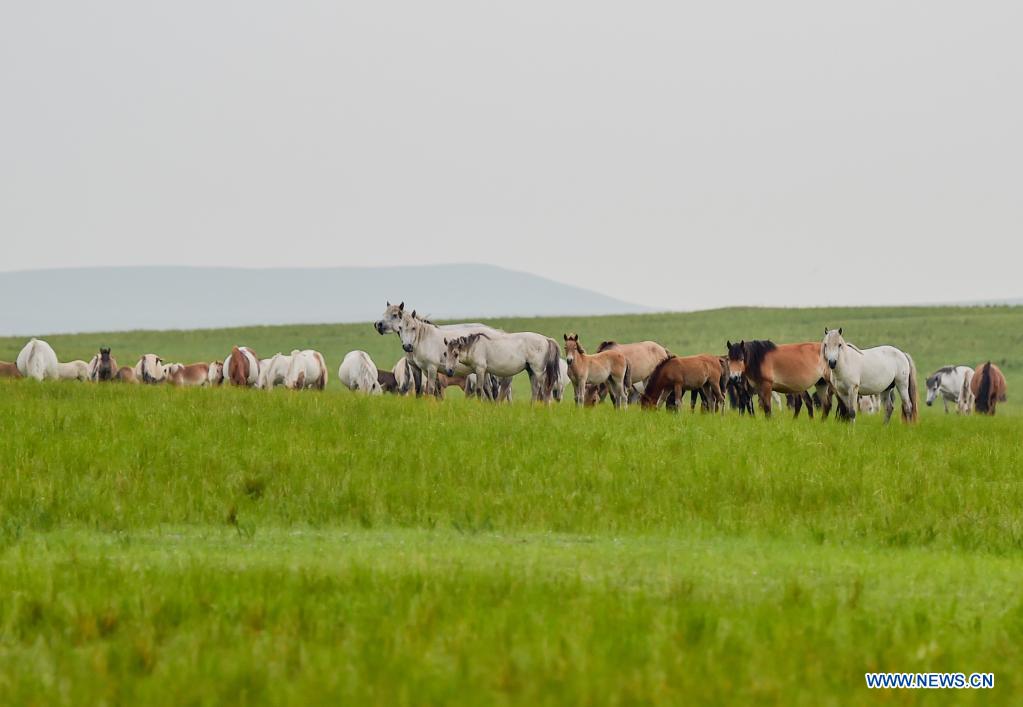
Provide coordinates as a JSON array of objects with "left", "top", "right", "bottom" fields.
[{"left": 444, "top": 332, "right": 561, "bottom": 402}]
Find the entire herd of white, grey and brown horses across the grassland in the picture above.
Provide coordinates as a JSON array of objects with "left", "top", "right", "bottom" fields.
[{"left": 0, "top": 302, "right": 1006, "bottom": 423}]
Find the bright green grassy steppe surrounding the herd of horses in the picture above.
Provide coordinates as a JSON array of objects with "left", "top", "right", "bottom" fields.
[{"left": 0, "top": 308, "right": 1023, "bottom": 705}]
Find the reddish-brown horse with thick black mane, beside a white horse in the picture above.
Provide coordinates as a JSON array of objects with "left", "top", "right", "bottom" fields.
[{"left": 726, "top": 340, "right": 831, "bottom": 416}]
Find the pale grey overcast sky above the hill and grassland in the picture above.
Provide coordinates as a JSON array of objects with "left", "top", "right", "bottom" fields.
[{"left": 0, "top": 0, "right": 1023, "bottom": 309}]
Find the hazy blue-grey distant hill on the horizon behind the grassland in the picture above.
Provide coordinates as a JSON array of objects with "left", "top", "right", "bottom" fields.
[{"left": 0, "top": 265, "right": 651, "bottom": 336}]
